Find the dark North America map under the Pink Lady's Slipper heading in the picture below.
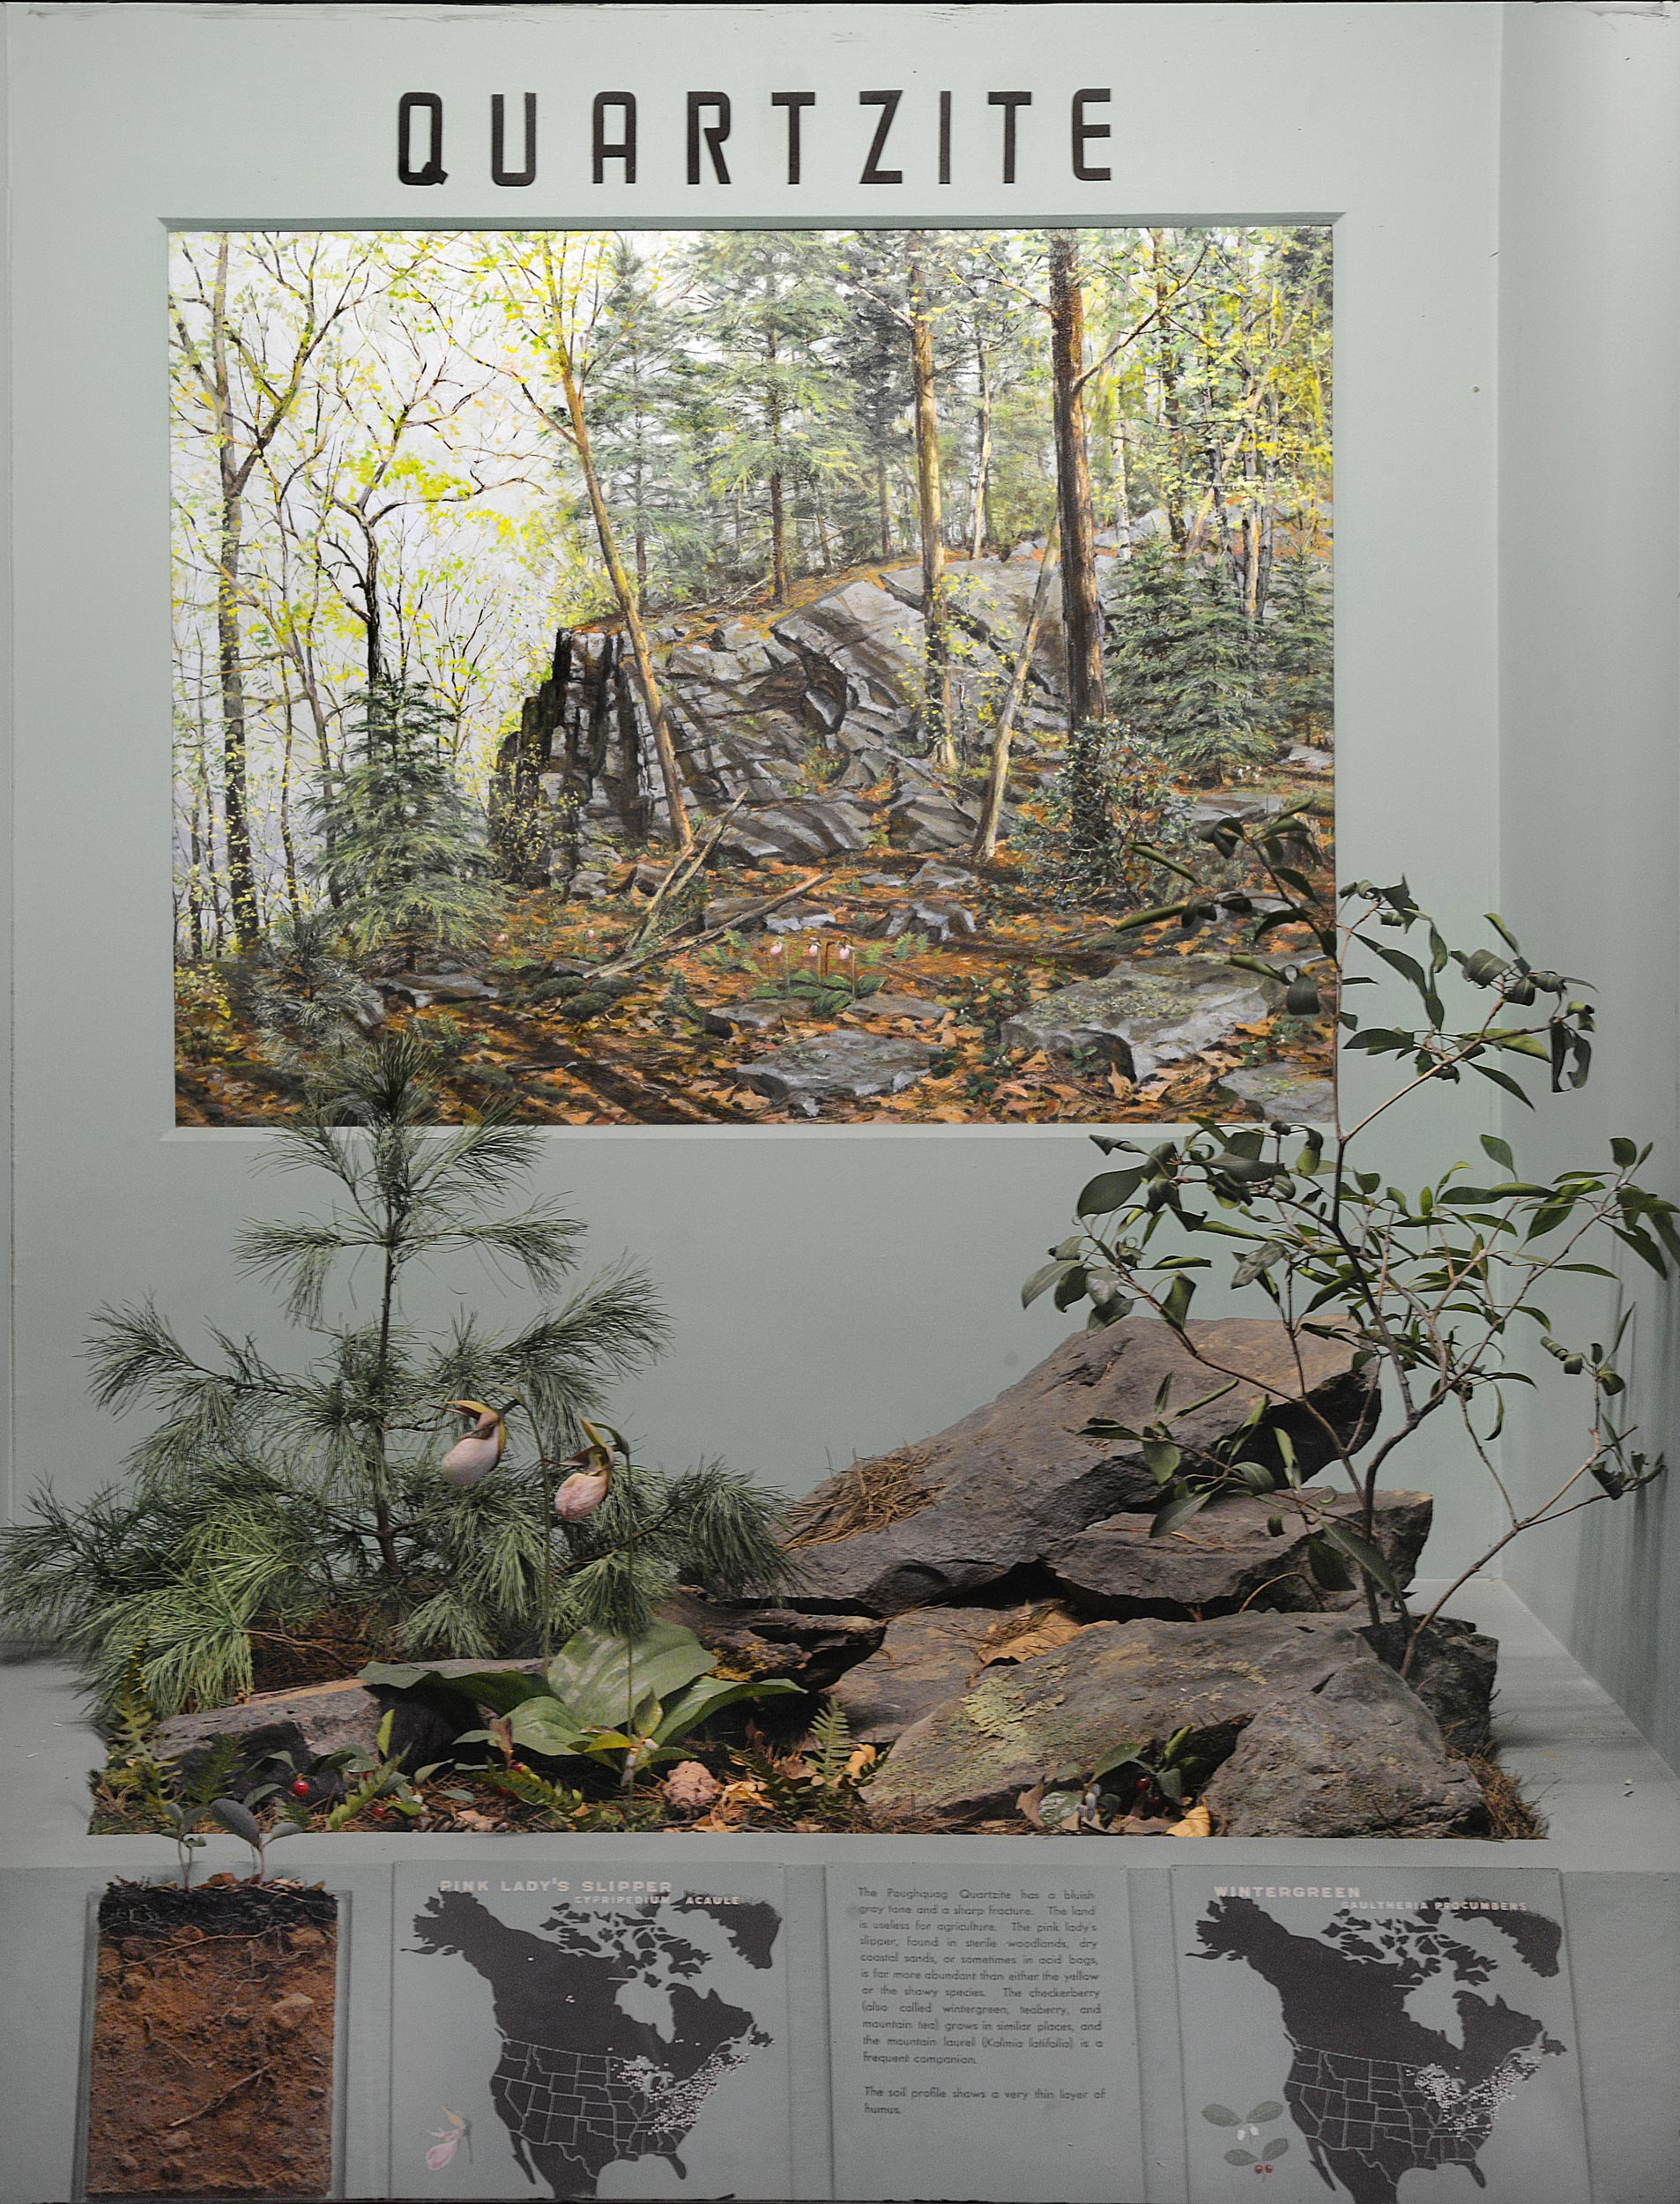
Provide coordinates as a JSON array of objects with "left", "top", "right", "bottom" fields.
[{"left": 414, "top": 1891, "right": 780, "bottom": 2198}]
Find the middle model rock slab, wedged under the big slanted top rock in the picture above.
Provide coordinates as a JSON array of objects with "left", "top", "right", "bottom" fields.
[{"left": 1045, "top": 1493, "right": 1435, "bottom": 1620}]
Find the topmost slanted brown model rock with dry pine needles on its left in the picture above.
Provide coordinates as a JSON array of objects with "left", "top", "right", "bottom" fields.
[{"left": 789, "top": 1318, "right": 1373, "bottom": 1616}]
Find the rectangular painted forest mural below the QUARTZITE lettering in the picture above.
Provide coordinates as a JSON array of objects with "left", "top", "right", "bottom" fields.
[{"left": 170, "top": 227, "right": 1334, "bottom": 1127}]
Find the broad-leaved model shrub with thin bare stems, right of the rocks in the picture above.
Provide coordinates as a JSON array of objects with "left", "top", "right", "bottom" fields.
[{"left": 1023, "top": 809, "right": 1680, "bottom": 1669}]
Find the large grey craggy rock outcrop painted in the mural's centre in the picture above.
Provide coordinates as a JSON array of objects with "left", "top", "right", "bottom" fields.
[{"left": 489, "top": 533, "right": 1153, "bottom": 895}]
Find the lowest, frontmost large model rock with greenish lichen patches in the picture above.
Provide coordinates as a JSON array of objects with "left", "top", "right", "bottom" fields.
[{"left": 865, "top": 1613, "right": 1482, "bottom": 1836}]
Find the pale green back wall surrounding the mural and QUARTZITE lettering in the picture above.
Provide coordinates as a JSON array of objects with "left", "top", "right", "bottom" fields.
[{"left": 0, "top": 4, "right": 1501, "bottom": 1556}]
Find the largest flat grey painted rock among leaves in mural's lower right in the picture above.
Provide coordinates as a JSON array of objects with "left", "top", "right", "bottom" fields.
[{"left": 1003, "top": 957, "right": 1283, "bottom": 1080}]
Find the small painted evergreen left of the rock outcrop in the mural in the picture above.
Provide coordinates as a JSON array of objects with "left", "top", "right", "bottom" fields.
[{"left": 313, "top": 679, "right": 498, "bottom": 968}]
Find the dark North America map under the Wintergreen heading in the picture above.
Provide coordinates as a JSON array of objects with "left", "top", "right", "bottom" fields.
[{"left": 1191, "top": 1895, "right": 1565, "bottom": 2204}]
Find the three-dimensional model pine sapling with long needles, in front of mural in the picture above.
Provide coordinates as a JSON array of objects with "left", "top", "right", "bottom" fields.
[{"left": 0, "top": 1034, "right": 789, "bottom": 1713}]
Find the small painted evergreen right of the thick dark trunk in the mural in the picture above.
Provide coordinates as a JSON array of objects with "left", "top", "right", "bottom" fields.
[{"left": 1109, "top": 538, "right": 1276, "bottom": 787}]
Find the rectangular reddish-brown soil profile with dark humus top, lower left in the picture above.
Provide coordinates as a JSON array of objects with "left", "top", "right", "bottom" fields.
[{"left": 88, "top": 1880, "right": 338, "bottom": 2198}]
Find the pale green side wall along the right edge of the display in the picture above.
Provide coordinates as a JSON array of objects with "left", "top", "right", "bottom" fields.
[{"left": 1499, "top": 7, "right": 1680, "bottom": 1761}]
